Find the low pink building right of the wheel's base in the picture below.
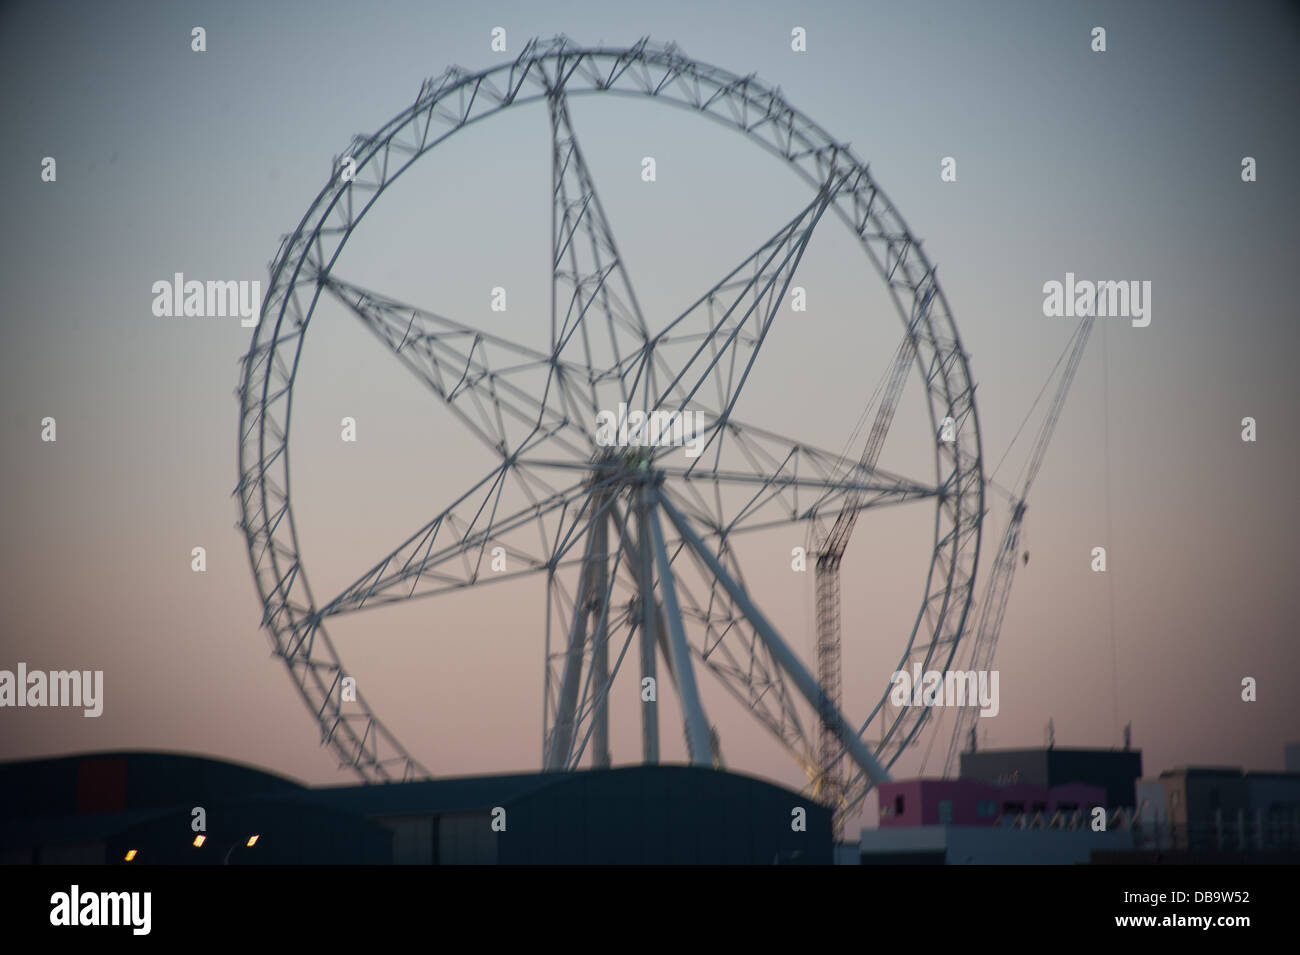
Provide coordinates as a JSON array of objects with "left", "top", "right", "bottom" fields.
[{"left": 878, "top": 780, "right": 1106, "bottom": 826}]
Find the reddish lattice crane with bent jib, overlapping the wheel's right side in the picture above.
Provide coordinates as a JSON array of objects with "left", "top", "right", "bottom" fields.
[{"left": 813, "top": 278, "right": 933, "bottom": 826}]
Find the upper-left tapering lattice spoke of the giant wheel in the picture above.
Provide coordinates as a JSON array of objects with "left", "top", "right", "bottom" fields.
[{"left": 320, "top": 275, "right": 592, "bottom": 460}]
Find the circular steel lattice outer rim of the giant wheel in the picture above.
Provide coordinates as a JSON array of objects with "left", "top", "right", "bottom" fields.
[{"left": 237, "top": 39, "right": 984, "bottom": 793}]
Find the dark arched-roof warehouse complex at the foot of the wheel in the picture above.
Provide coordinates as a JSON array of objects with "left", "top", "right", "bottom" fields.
[{"left": 0, "top": 752, "right": 832, "bottom": 865}]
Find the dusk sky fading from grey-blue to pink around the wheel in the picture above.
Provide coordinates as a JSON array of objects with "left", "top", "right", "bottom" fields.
[{"left": 0, "top": 0, "right": 1300, "bottom": 831}]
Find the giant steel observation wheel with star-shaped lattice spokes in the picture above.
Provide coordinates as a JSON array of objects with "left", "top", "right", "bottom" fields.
[{"left": 235, "top": 38, "right": 984, "bottom": 813}]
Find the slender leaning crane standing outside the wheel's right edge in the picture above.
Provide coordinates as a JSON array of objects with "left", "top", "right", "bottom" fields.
[{"left": 944, "top": 316, "right": 1093, "bottom": 776}]
